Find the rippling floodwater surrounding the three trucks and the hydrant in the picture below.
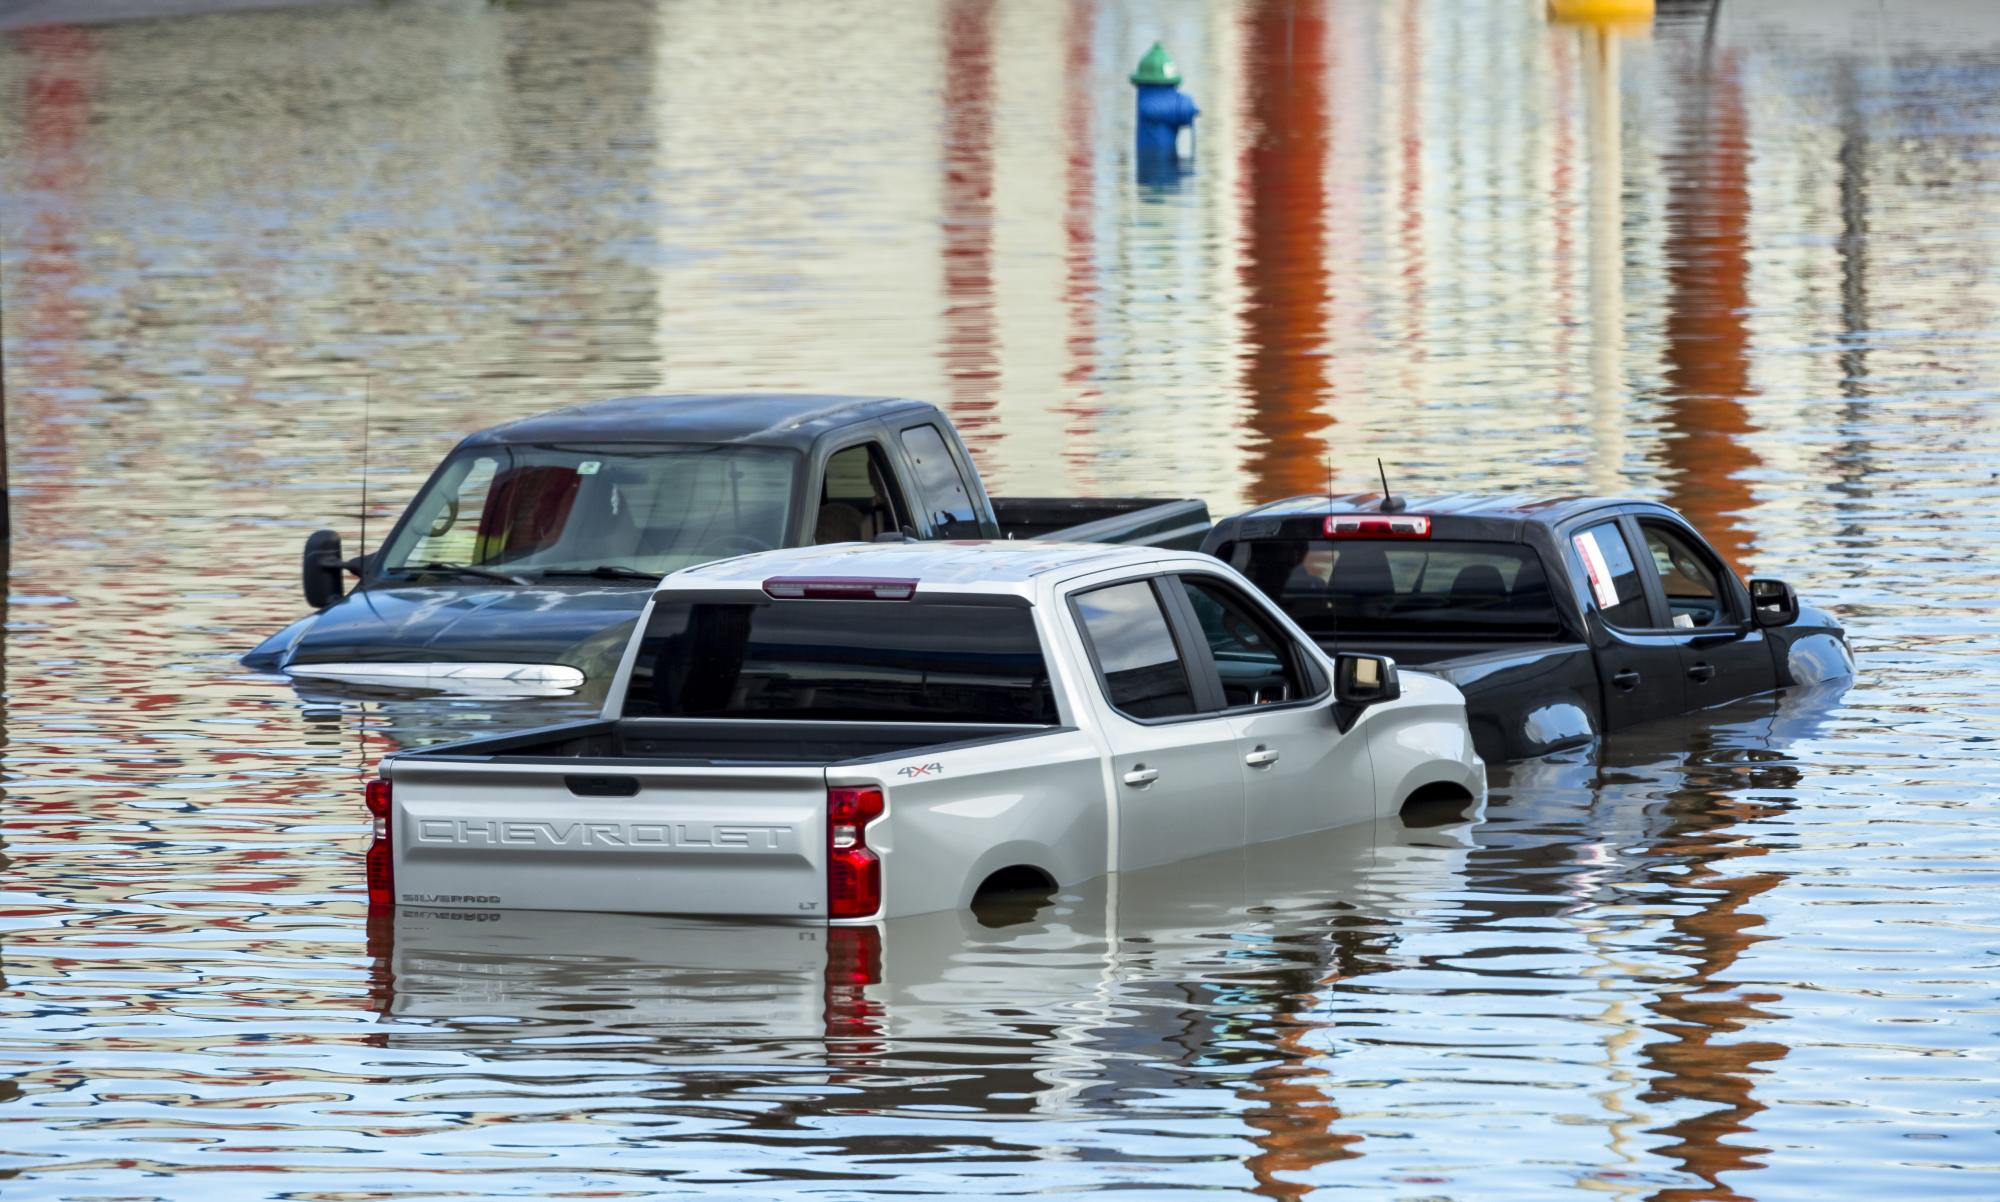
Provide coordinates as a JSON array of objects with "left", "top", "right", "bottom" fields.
[{"left": 0, "top": 0, "right": 2000, "bottom": 1202}]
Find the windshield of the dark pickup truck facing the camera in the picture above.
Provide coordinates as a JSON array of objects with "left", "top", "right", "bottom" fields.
[{"left": 382, "top": 446, "right": 796, "bottom": 580}]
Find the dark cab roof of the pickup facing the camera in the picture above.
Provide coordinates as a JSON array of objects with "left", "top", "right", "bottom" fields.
[{"left": 464, "top": 392, "right": 938, "bottom": 450}]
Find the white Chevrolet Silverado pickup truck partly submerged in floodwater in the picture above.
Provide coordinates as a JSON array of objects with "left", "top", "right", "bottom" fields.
[{"left": 368, "top": 542, "right": 1486, "bottom": 922}]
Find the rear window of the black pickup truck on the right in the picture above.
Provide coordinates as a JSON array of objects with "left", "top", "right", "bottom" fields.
[{"left": 1228, "top": 538, "right": 1562, "bottom": 636}]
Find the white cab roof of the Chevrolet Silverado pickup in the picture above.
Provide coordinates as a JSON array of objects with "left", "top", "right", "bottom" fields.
[{"left": 660, "top": 540, "right": 1198, "bottom": 594}]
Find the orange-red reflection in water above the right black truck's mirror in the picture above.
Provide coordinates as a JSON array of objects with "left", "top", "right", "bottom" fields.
[{"left": 1662, "top": 54, "right": 1758, "bottom": 572}]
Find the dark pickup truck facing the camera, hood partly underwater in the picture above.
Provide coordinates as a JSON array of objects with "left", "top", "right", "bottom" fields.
[{"left": 242, "top": 394, "right": 1208, "bottom": 696}]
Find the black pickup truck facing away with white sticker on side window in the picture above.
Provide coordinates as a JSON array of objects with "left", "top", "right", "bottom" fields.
[{"left": 1202, "top": 494, "right": 1854, "bottom": 760}]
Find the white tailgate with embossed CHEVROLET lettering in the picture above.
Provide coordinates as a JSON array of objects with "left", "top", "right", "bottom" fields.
[{"left": 390, "top": 760, "right": 826, "bottom": 918}]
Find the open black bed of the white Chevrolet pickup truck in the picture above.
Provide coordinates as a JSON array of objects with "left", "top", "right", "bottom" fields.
[{"left": 398, "top": 718, "right": 1050, "bottom": 766}]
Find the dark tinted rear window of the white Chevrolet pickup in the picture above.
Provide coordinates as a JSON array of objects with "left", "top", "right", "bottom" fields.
[{"left": 624, "top": 600, "right": 1056, "bottom": 726}]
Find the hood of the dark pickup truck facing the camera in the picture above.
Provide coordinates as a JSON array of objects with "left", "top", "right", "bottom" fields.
[{"left": 258, "top": 584, "right": 652, "bottom": 678}]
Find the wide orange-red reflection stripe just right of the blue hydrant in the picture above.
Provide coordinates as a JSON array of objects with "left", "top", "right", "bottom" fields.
[{"left": 1242, "top": 0, "right": 1330, "bottom": 500}]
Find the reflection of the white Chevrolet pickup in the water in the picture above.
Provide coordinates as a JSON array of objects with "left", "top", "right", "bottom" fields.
[{"left": 372, "top": 806, "right": 1474, "bottom": 1080}]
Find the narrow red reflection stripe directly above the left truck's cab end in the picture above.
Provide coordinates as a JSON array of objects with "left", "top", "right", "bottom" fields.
[{"left": 944, "top": 0, "right": 1000, "bottom": 454}]
